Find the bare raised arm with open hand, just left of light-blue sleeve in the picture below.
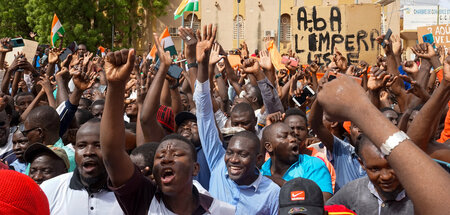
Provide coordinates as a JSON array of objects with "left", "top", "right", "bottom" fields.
[{"left": 140, "top": 35, "right": 172, "bottom": 142}]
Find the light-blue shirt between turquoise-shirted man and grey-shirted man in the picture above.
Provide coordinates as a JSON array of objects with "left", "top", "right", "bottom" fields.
[{"left": 331, "top": 137, "right": 367, "bottom": 191}]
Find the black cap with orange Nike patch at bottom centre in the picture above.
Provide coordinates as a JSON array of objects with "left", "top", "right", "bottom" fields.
[{"left": 280, "top": 178, "right": 324, "bottom": 215}]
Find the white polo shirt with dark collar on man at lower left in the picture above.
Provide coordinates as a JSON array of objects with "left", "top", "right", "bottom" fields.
[{"left": 41, "top": 172, "right": 124, "bottom": 215}]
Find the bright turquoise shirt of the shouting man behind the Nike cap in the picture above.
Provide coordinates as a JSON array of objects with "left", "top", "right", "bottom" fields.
[{"left": 261, "top": 154, "right": 333, "bottom": 194}]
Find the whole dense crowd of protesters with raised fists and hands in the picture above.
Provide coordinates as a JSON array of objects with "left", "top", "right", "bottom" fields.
[{"left": 0, "top": 22, "right": 450, "bottom": 215}]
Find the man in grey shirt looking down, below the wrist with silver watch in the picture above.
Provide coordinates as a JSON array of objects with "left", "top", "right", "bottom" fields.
[{"left": 327, "top": 134, "right": 414, "bottom": 215}]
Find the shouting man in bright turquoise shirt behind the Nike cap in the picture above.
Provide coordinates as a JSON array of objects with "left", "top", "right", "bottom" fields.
[{"left": 261, "top": 122, "right": 333, "bottom": 201}]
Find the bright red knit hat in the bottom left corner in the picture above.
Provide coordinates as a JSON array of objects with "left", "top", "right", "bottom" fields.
[{"left": 0, "top": 170, "right": 50, "bottom": 215}]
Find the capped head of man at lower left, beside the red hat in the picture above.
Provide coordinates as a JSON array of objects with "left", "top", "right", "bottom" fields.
[{"left": 24, "top": 143, "right": 70, "bottom": 184}]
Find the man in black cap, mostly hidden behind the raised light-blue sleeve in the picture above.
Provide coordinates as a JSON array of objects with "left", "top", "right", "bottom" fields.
[{"left": 175, "top": 111, "right": 211, "bottom": 190}]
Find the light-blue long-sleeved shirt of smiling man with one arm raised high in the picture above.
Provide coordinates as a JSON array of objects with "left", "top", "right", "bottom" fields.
[{"left": 194, "top": 80, "right": 280, "bottom": 215}]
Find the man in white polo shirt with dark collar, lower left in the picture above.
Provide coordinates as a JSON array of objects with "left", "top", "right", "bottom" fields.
[{"left": 41, "top": 119, "right": 123, "bottom": 215}]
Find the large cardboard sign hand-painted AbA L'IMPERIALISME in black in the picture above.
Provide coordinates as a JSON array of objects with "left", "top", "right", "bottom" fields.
[{"left": 291, "top": 4, "right": 381, "bottom": 65}]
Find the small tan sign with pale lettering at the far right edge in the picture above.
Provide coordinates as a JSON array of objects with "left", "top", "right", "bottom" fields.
[{"left": 417, "top": 24, "right": 450, "bottom": 53}]
